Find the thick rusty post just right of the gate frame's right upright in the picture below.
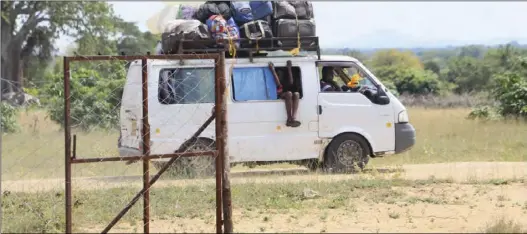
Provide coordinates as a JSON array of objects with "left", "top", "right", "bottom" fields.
[{"left": 216, "top": 52, "right": 233, "bottom": 233}]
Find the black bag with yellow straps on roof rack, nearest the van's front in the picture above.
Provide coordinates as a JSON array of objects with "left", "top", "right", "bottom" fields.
[{"left": 273, "top": 19, "right": 316, "bottom": 47}]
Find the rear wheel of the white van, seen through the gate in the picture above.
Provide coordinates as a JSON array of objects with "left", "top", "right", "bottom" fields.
[{"left": 152, "top": 138, "right": 216, "bottom": 178}]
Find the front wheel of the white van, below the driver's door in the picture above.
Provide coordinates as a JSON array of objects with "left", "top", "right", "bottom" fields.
[{"left": 322, "top": 133, "right": 371, "bottom": 173}]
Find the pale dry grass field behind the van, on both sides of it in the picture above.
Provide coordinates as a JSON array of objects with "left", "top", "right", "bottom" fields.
[{"left": 2, "top": 108, "right": 527, "bottom": 180}]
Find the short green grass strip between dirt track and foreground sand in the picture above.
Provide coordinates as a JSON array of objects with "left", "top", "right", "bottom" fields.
[{"left": 2, "top": 179, "right": 458, "bottom": 232}]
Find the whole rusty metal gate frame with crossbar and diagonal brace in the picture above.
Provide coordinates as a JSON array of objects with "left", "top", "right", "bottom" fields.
[{"left": 64, "top": 51, "right": 232, "bottom": 233}]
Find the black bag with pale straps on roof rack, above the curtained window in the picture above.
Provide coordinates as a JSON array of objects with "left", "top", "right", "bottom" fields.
[{"left": 240, "top": 20, "right": 273, "bottom": 48}]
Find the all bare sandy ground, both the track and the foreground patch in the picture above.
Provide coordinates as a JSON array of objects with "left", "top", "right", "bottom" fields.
[{"left": 2, "top": 162, "right": 527, "bottom": 233}]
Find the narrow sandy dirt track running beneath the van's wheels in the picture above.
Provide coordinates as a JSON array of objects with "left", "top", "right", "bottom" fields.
[{"left": 2, "top": 162, "right": 527, "bottom": 192}]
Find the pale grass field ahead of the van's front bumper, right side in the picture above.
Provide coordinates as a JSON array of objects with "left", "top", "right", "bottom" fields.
[{"left": 370, "top": 108, "right": 527, "bottom": 166}]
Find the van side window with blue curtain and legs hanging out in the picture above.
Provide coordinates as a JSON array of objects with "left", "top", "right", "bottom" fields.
[{"left": 232, "top": 67, "right": 302, "bottom": 101}]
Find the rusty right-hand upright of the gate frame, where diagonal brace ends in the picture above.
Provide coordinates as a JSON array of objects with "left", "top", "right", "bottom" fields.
[{"left": 214, "top": 53, "right": 225, "bottom": 233}]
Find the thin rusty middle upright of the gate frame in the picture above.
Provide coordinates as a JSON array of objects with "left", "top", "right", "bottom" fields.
[{"left": 141, "top": 58, "right": 150, "bottom": 233}]
